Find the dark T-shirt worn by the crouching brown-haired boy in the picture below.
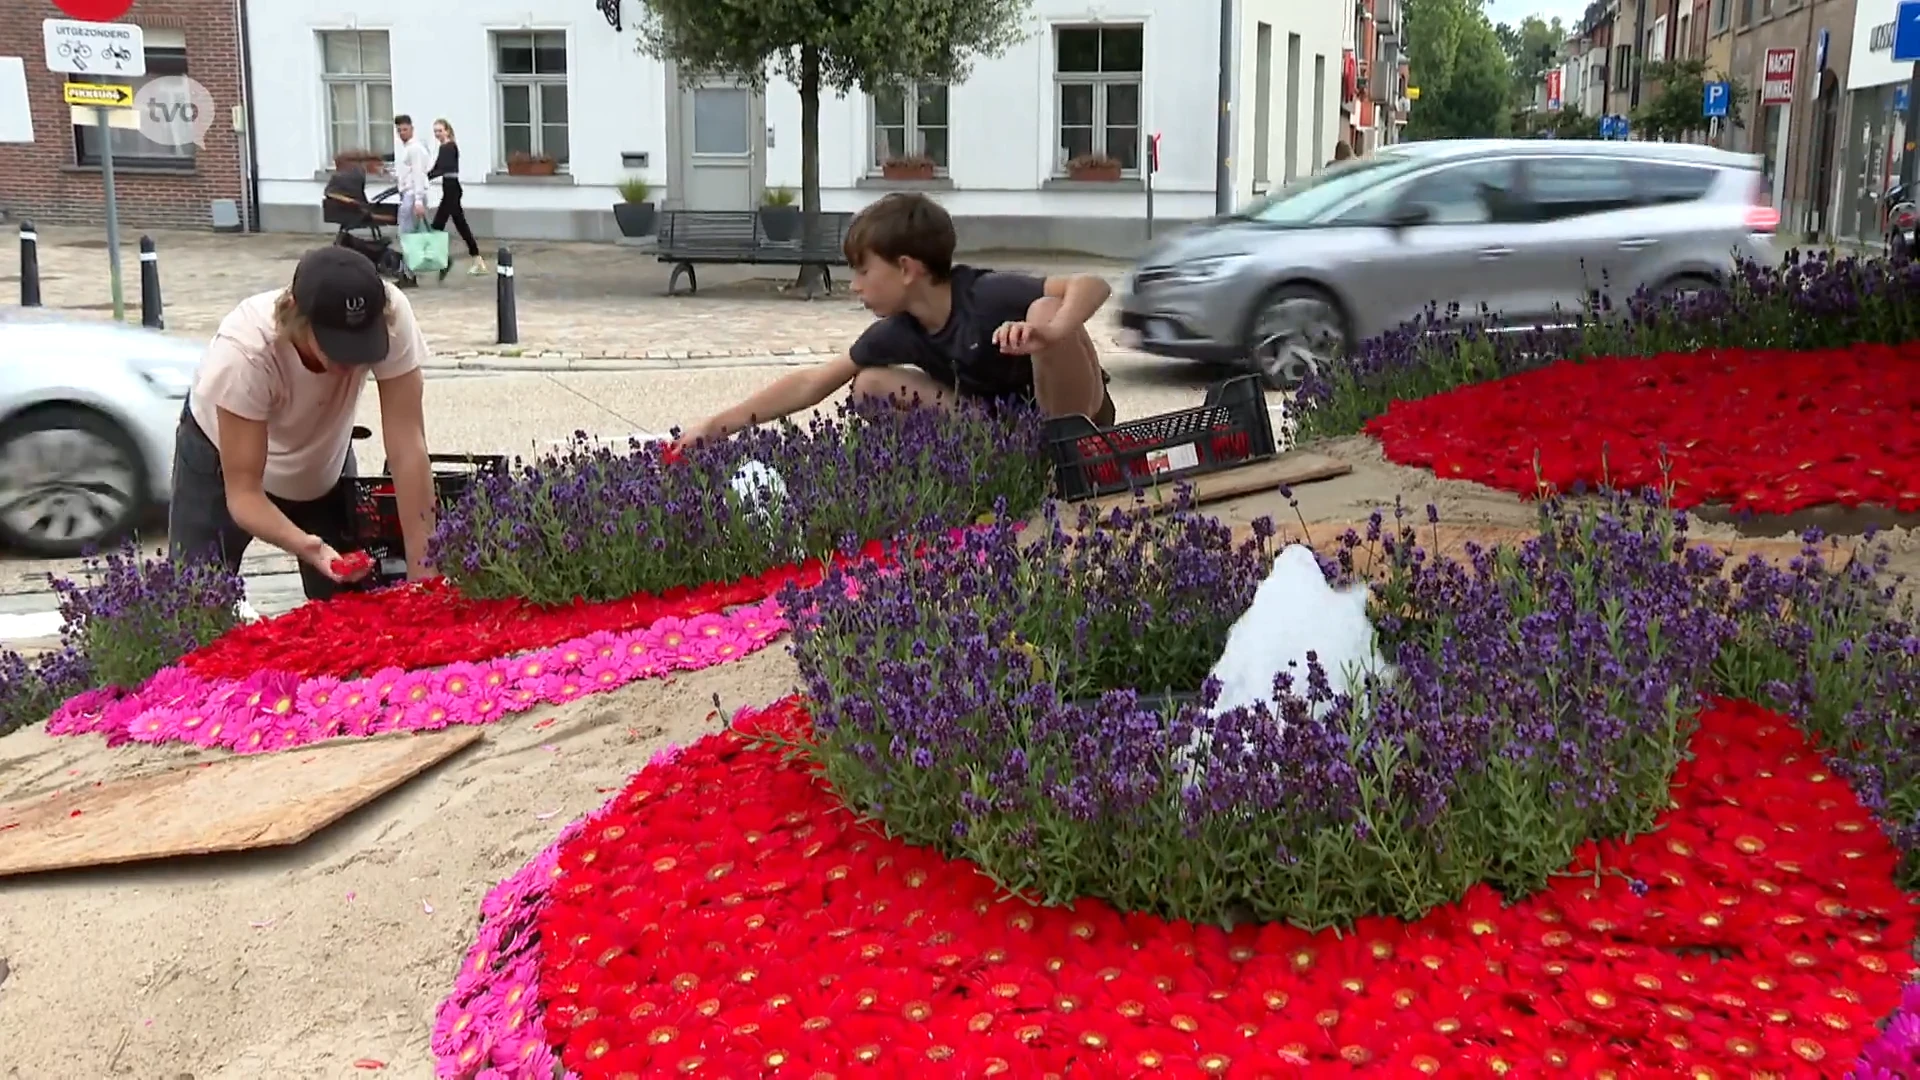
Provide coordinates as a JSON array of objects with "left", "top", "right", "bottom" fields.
[{"left": 849, "top": 265, "right": 1046, "bottom": 400}]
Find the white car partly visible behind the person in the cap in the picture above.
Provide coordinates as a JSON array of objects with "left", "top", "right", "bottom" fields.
[{"left": 0, "top": 307, "right": 202, "bottom": 557}]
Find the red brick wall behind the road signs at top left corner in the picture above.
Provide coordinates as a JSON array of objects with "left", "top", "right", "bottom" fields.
[{"left": 0, "top": 0, "right": 244, "bottom": 229}]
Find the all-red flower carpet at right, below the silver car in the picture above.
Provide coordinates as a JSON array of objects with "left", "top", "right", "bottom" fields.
[{"left": 1365, "top": 344, "right": 1920, "bottom": 513}]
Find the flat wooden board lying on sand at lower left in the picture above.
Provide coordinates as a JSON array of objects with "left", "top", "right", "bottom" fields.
[{"left": 0, "top": 726, "right": 484, "bottom": 878}]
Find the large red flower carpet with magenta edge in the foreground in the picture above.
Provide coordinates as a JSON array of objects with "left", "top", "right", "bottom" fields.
[{"left": 434, "top": 700, "right": 1914, "bottom": 1080}]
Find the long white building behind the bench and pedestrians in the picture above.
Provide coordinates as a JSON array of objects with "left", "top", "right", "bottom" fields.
[{"left": 248, "top": 0, "right": 1352, "bottom": 254}]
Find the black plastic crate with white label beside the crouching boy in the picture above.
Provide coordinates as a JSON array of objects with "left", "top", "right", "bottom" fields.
[{"left": 1046, "top": 375, "right": 1277, "bottom": 502}]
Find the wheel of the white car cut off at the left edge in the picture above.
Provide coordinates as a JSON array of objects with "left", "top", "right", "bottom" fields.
[{"left": 0, "top": 407, "right": 150, "bottom": 559}]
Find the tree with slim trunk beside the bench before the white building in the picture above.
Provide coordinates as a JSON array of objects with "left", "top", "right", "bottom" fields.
[{"left": 637, "top": 0, "right": 1029, "bottom": 296}]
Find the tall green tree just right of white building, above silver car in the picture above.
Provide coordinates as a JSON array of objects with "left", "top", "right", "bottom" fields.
[{"left": 1407, "top": 0, "right": 1513, "bottom": 138}]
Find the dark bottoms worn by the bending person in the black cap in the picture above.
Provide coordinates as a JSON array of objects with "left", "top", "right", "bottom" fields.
[{"left": 167, "top": 395, "right": 357, "bottom": 600}]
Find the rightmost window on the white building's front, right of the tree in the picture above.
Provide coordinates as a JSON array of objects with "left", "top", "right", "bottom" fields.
[{"left": 1054, "top": 27, "right": 1146, "bottom": 173}]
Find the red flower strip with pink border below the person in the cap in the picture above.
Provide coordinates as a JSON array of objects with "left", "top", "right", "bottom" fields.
[{"left": 48, "top": 544, "right": 889, "bottom": 753}]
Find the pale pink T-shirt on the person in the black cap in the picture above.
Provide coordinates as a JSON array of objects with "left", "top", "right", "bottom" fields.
[{"left": 188, "top": 286, "right": 428, "bottom": 502}]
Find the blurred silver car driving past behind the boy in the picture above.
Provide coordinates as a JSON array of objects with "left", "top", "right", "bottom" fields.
[{"left": 1119, "top": 140, "right": 1780, "bottom": 388}]
